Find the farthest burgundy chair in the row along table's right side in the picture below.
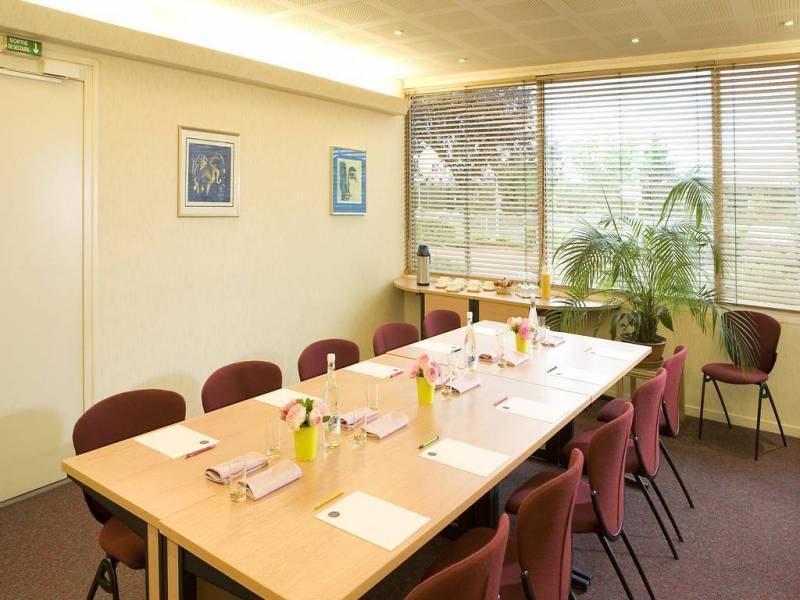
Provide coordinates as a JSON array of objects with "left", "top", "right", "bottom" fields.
[{"left": 597, "top": 346, "right": 694, "bottom": 508}]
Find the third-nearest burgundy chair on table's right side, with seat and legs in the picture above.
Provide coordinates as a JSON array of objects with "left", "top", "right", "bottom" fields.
[{"left": 506, "top": 402, "right": 655, "bottom": 600}]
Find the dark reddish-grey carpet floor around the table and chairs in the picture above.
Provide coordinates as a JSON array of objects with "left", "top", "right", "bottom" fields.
[{"left": 0, "top": 403, "right": 800, "bottom": 600}]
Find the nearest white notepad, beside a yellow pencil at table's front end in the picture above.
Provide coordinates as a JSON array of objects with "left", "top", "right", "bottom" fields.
[{"left": 316, "top": 492, "right": 430, "bottom": 551}]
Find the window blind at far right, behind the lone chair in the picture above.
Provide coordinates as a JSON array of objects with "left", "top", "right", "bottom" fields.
[{"left": 719, "top": 62, "right": 800, "bottom": 309}]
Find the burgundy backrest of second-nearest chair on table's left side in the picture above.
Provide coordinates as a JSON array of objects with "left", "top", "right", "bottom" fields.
[{"left": 201, "top": 360, "right": 283, "bottom": 412}]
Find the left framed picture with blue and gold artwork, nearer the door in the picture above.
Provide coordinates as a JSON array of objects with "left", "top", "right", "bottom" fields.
[{"left": 178, "top": 127, "right": 239, "bottom": 217}]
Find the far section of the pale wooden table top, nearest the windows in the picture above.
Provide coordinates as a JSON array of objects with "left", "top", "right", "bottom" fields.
[{"left": 389, "top": 321, "right": 650, "bottom": 400}]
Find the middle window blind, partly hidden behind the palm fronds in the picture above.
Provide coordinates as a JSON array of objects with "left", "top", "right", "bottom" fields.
[{"left": 544, "top": 69, "right": 713, "bottom": 285}]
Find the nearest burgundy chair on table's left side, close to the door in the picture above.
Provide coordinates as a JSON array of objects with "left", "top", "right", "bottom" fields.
[{"left": 72, "top": 390, "right": 186, "bottom": 600}]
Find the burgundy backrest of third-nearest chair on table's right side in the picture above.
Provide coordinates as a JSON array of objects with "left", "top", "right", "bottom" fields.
[{"left": 586, "top": 402, "right": 633, "bottom": 537}]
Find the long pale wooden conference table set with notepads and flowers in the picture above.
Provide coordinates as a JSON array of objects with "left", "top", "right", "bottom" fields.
[{"left": 62, "top": 322, "right": 649, "bottom": 600}]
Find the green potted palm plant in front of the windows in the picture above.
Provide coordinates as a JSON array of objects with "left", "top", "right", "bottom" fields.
[{"left": 555, "top": 171, "right": 754, "bottom": 367}]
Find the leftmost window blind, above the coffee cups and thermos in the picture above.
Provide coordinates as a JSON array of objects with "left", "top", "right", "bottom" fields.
[{"left": 408, "top": 85, "right": 539, "bottom": 277}]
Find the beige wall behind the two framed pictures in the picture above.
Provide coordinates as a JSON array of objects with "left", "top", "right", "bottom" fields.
[{"left": 92, "top": 52, "right": 404, "bottom": 413}]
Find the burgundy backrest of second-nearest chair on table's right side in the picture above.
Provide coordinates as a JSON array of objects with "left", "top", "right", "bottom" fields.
[{"left": 517, "top": 448, "right": 583, "bottom": 600}]
